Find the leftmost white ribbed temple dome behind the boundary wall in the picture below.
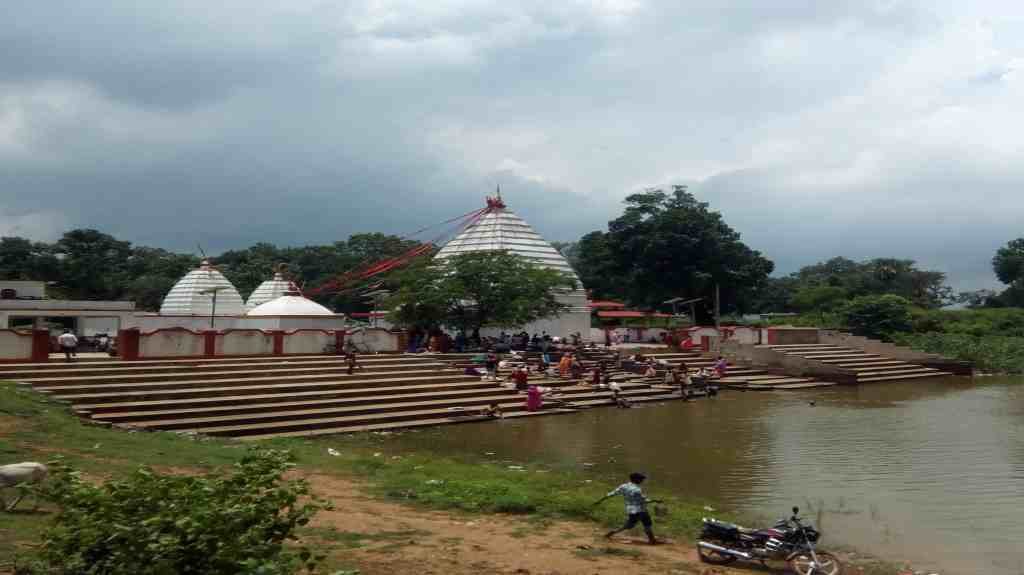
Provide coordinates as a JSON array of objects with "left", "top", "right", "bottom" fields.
[{"left": 160, "top": 260, "right": 245, "bottom": 316}]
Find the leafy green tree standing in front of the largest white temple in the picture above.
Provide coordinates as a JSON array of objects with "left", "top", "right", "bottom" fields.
[{"left": 385, "top": 251, "right": 574, "bottom": 333}]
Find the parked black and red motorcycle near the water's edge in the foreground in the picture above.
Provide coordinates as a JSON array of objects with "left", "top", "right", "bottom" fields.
[{"left": 697, "top": 507, "right": 842, "bottom": 575}]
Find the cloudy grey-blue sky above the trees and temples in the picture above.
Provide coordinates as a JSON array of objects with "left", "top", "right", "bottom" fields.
[{"left": 0, "top": 0, "right": 1024, "bottom": 290}]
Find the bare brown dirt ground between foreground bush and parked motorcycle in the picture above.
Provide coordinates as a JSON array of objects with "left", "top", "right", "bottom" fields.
[{"left": 309, "top": 475, "right": 768, "bottom": 575}]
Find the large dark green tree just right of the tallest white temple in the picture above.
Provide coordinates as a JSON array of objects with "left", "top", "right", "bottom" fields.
[{"left": 579, "top": 186, "right": 774, "bottom": 312}]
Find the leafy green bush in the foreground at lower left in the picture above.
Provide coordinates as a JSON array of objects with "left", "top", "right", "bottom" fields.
[{"left": 27, "top": 450, "right": 326, "bottom": 575}]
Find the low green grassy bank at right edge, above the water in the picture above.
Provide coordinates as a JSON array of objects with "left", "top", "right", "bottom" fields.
[{"left": 893, "top": 333, "right": 1024, "bottom": 373}]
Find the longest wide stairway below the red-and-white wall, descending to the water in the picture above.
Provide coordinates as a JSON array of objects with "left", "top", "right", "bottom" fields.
[{"left": 0, "top": 354, "right": 679, "bottom": 439}]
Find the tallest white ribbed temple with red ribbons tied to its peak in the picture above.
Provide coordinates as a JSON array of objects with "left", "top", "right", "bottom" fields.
[{"left": 434, "top": 196, "right": 590, "bottom": 339}]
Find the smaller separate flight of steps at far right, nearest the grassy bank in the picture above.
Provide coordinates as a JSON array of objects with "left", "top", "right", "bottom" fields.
[{"left": 761, "top": 344, "right": 948, "bottom": 384}]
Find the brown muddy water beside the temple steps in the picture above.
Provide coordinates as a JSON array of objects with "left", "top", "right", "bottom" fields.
[{"left": 385, "top": 378, "right": 1024, "bottom": 575}]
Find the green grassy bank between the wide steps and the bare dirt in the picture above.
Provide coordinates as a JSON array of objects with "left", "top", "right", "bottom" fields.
[{"left": 0, "top": 384, "right": 707, "bottom": 564}]
